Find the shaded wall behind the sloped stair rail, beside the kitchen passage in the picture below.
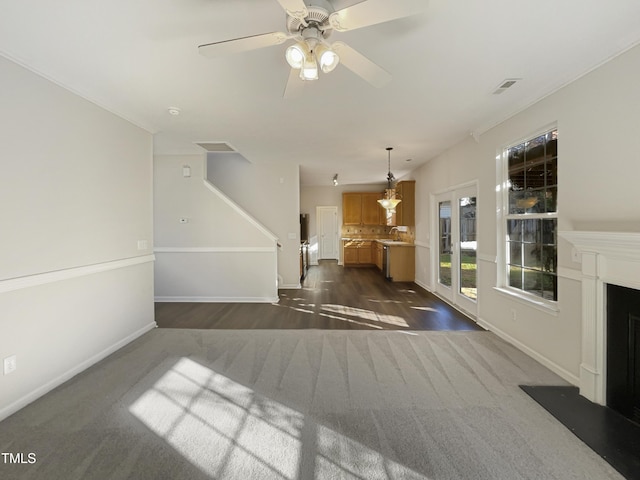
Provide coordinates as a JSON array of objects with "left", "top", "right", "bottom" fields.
[{"left": 207, "top": 153, "right": 300, "bottom": 288}]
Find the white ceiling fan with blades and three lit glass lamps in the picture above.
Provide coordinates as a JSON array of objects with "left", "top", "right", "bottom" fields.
[{"left": 198, "top": 0, "right": 428, "bottom": 97}]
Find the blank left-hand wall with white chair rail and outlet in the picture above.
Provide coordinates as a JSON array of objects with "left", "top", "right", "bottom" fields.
[{"left": 0, "top": 58, "right": 155, "bottom": 419}]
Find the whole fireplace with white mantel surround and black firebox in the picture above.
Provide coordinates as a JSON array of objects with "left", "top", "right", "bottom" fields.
[{"left": 559, "top": 231, "right": 640, "bottom": 406}]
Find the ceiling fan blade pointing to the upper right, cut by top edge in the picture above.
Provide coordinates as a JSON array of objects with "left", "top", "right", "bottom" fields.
[{"left": 329, "top": 0, "right": 429, "bottom": 32}]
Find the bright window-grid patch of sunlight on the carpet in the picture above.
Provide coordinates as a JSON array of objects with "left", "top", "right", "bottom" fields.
[{"left": 129, "top": 357, "right": 428, "bottom": 480}]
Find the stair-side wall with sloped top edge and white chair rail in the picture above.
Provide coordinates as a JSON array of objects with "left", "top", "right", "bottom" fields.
[{"left": 154, "top": 154, "right": 278, "bottom": 302}]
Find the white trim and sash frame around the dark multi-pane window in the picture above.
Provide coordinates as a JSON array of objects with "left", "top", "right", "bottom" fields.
[{"left": 494, "top": 123, "right": 560, "bottom": 315}]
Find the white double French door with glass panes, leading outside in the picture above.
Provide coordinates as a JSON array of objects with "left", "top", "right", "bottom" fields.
[{"left": 432, "top": 185, "right": 478, "bottom": 316}]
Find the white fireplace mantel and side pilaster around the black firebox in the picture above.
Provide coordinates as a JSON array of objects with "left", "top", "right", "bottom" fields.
[{"left": 558, "top": 231, "right": 640, "bottom": 405}]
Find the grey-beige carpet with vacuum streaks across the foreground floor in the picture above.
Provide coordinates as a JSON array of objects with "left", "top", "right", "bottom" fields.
[{"left": 0, "top": 329, "right": 622, "bottom": 480}]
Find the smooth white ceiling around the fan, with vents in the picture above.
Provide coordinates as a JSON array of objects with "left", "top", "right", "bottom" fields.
[{"left": 0, "top": 0, "right": 640, "bottom": 185}]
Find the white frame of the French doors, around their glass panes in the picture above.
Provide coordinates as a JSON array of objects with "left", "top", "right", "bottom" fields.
[{"left": 431, "top": 181, "right": 478, "bottom": 318}]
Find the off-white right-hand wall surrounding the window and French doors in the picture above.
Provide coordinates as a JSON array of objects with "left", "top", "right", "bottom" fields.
[{"left": 412, "top": 47, "right": 640, "bottom": 383}]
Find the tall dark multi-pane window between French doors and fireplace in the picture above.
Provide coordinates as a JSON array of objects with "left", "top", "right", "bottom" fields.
[{"left": 503, "top": 129, "right": 558, "bottom": 301}]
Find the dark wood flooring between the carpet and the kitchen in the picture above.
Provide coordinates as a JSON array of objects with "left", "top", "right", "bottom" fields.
[{"left": 155, "top": 260, "right": 482, "bottom": 330}]
